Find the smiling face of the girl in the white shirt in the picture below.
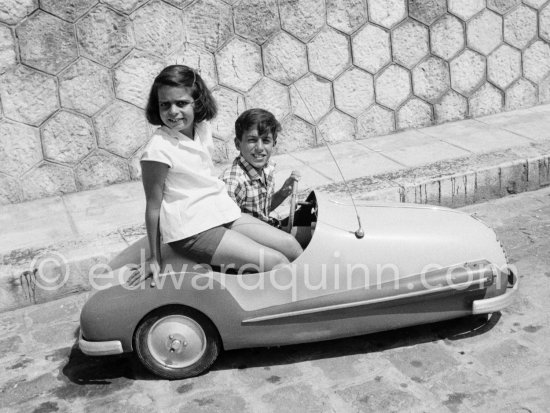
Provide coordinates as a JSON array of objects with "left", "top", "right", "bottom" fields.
[{"left": 158, "top": 86, "right": 195, "bottom": 139}]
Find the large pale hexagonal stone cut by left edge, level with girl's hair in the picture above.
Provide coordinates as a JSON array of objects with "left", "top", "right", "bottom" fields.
[{"left": 0, "top": 66, "right": 59, "bottom": 126}]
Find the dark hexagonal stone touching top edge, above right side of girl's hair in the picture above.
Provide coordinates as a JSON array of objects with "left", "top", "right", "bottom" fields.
[{"left": 183, "top": 0, "right": 233, "bottom": 52}]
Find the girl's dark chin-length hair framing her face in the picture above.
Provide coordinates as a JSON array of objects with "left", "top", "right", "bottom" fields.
[{"left": 145, "top": 65, "right": 218, "bottom": 125}]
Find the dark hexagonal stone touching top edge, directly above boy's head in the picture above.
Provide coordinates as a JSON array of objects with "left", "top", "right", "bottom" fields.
[{"left": 233, "top": 0, "right": 280, "bottom": 44}]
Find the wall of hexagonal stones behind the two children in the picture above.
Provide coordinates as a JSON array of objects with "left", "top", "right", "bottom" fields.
[{"left": 0, "top": 0, "right": 550, "bottom": 204}]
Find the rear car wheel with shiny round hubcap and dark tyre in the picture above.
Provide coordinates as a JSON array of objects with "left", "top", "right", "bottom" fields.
[{"left": 134, "top": 307, "right": 221, "bottom": 380}]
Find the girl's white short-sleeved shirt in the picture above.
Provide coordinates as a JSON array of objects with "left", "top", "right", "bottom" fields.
[{"left": 141, "top": 121, "right": 241, "bottom": 243}]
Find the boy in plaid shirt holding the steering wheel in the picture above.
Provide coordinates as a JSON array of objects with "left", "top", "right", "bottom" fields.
[{"left": 220, "top": 109, "right": 300, "bottom": 226}]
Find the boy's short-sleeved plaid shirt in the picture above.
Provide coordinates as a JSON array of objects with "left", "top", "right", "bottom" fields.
[{"left": 220, "top": 155, "right": 275, "bottom": 222}]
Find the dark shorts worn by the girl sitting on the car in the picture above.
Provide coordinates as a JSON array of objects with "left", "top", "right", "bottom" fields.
[{"left": 168, "top": 222, "right": 232, "bottom": 264}]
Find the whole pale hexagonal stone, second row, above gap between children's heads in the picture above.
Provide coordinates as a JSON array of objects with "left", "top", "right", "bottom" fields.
[{"left": 216, "top": 38, "right": 262, "bottom": 92}]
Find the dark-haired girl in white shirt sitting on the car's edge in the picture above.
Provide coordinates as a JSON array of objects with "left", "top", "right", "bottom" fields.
[{"left": 128, "top": 65, "right": 302, "bottom": 286}]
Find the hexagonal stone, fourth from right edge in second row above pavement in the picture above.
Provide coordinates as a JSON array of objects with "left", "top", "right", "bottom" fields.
[{"left": 412, "top": 56, "right": 450, "bottom": 102}]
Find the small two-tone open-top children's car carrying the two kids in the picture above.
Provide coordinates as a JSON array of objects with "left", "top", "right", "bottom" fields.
[{"left": 79, "top": 192, "right": 518, "bottom": 379}]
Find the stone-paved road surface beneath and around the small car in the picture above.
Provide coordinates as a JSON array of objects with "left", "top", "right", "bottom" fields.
[{"left": 0, "top": 189, "right": 550, "bottom": 413}]
